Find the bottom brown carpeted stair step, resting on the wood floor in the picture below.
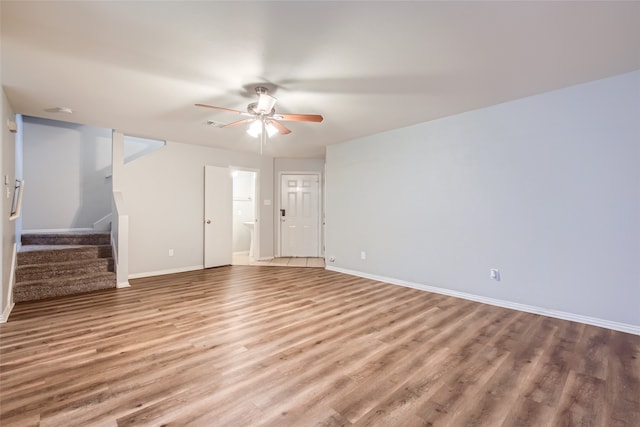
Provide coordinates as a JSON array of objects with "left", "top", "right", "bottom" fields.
[{"left": 13, "top": 272, "right": 116, "bottom": 302}]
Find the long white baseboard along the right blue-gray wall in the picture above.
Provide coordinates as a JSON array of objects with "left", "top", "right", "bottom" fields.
[{"left": 325, "top": 266, "right": 640, "bottom": 335}]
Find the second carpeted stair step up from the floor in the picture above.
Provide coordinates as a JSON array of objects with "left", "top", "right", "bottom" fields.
[{"left": 16, "top": 258, "right": 113, "bottom": 282}]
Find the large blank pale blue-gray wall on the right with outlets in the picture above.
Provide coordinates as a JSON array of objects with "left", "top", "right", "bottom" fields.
[{"left": 326, "top": 71, "right": 640, "bottom": 333}]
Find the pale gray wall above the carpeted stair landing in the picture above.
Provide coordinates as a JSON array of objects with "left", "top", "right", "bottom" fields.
[{"left": 22, "top": 117, "right": 111, "bottom": 230}]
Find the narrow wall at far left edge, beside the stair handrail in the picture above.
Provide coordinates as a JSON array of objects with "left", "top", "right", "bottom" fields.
[{"left": 0, "top": 88, "right": 16, "bottom": 323}]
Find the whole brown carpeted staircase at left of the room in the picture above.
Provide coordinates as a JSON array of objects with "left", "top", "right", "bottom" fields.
[{"left": 13, "top": 233, "right": 116, "bottom": 302}]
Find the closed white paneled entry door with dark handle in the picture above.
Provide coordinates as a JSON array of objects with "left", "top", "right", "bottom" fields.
[{"left": 279, "top": 174, "right": 320, "bottom": 257}]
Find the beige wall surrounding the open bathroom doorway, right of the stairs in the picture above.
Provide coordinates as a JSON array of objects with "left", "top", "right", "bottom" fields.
[{"left": 120, "top": 141, "right": 273, "bottom": 277}]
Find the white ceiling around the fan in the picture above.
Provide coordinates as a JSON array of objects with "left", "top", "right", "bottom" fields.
[{"left": 0, "top": 0, "right": 640, "bottom": 157}]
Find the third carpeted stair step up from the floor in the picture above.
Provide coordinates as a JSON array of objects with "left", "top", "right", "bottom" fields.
[{"left": 18, "top": 245, "right": 112, "bottom": 266}]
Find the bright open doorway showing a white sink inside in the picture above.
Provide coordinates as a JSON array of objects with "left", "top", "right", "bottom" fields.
[{"left": 231, "top": 169, "right": 260, "bottom": 265}]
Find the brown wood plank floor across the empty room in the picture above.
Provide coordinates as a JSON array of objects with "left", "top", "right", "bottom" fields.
[{"left": 0, "top": 266, "right": 640, "bottom": 427}]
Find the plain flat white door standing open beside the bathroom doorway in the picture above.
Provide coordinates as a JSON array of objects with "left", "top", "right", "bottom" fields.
[{"left": 204, "top": 166, "right": 233, "bottom": 268}]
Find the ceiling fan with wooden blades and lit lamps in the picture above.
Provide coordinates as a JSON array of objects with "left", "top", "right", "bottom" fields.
[{"left": 195, "top": 86, "right": 323, "bottom": 137}]
